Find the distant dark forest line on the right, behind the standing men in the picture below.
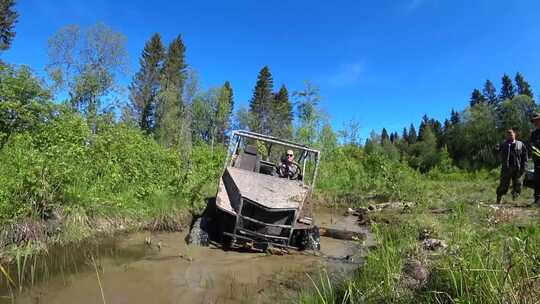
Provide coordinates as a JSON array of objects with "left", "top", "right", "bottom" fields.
[{"left": 380, "top": 73, "right": 538, "bottom": 172}]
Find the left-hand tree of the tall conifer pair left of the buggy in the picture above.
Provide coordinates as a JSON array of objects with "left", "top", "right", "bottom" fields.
[{"left": 129, "top": 34, "right": 165, "bottom": 133}]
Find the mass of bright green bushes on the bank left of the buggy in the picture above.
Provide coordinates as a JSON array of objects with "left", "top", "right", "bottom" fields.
[{"left": 0, "top": 61, "right": 224, "bottom": 223}]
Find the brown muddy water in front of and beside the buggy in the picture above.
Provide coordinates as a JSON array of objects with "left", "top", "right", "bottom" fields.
[{"left": 0, "top": 212, "right": 364, "bottom": 304}]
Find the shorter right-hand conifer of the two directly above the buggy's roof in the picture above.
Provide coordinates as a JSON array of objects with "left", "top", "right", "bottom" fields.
[{"left": 271, "top": 85, "right": 293, "bottom": 139}]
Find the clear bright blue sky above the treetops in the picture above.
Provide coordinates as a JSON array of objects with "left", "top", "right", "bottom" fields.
[{"left": 1, "top": 0, "right": 540, "bottom": 137}]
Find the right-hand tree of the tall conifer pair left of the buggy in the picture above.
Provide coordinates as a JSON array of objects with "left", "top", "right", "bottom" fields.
[{"left": 156, "top": 36, "right": 191, "bottom": 148}]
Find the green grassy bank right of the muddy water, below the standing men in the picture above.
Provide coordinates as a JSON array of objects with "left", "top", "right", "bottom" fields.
[{"left": 297, "top": 175, "right": 540, "bottom": 304}]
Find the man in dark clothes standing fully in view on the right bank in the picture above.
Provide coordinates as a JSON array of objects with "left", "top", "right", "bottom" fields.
[{"left": 497, "top": 129, "right": 528, "bottom": 204}]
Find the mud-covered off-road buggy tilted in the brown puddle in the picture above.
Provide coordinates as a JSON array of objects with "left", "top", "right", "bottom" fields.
[{"left": 188, "top": 131, "right": 320, "bottom": 250}]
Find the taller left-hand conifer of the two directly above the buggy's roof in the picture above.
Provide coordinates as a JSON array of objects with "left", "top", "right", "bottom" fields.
[{"left": 249, "top": 66, "right": 274, "bottom": 134}]
